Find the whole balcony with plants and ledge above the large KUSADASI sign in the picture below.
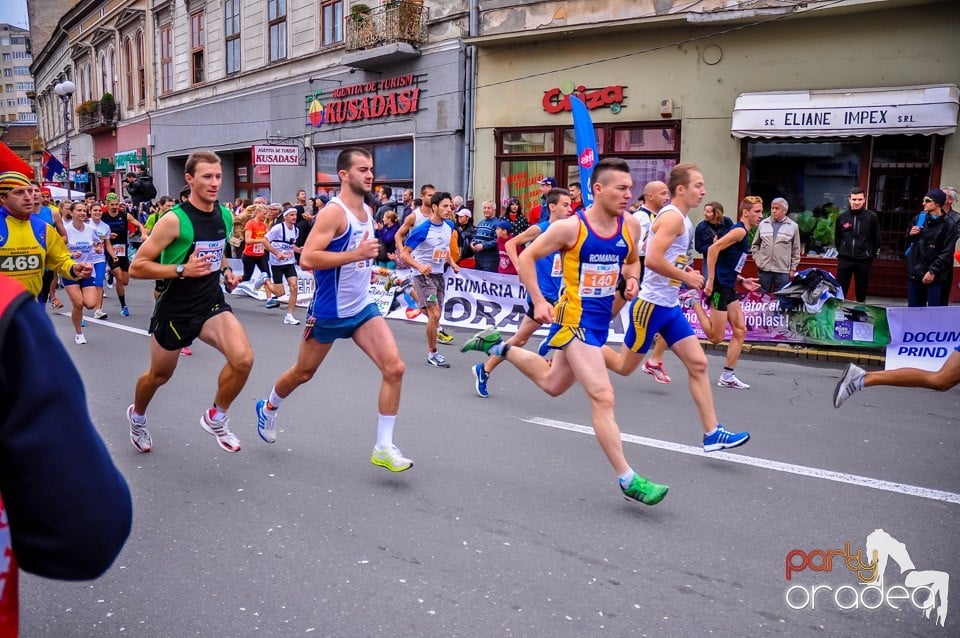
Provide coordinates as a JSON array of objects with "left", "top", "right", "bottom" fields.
[{"left": 344, "top": 0, "right": 427, "bottom": 68}]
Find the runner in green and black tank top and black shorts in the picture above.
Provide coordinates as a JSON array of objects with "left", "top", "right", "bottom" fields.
[{"left": 127, "top": 151, "right": 253, "bottom": 452}]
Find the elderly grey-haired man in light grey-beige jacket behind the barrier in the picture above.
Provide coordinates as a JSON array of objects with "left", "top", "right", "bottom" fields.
[{"left": 751, "top": 197, "right": 800, "bottom": 292}]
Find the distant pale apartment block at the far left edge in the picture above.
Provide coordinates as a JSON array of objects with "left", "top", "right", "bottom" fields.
[{"left": 0, "top": 24, "right": 37, "bottom": 124}]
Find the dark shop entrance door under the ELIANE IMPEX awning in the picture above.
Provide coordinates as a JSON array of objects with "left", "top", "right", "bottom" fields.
[{"left": 867, "top": 164, "right": 930, "bottom": 297}]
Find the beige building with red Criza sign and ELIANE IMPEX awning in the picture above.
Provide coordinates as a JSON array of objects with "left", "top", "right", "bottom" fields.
[{"left": 470, "top": 0, "right": 960, "bottom": 294}]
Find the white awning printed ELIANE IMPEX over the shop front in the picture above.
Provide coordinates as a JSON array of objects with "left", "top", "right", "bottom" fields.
[{"left": 730, "top": 84, "right": 960, "bottom": 138}]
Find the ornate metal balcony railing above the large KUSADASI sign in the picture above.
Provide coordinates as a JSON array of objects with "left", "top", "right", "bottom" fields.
[{"left": 346, "top": 0, "right": 427, "bottom": 51}]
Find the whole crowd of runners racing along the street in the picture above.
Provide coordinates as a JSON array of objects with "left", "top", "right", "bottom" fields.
[{"left": 0, "top": 148, "right": 960, "bottom": 505}]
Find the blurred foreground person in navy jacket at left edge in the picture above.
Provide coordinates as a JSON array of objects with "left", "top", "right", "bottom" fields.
[{"left": 0, "top": 275, "right": 133, "bottom": 636}]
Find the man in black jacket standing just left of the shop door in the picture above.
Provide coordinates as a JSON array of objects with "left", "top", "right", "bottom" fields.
[{"left": 833, "top": 186, "right": 880, "bottom": 303}]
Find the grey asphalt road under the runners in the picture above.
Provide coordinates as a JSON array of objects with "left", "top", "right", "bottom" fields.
[{"left": 21, "top": 282, "right": 960, "bottom": 638}]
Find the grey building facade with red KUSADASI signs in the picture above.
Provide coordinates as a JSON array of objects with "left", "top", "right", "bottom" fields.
[{"left": 151, "top": 0, "right": 465, "bottom": 201}]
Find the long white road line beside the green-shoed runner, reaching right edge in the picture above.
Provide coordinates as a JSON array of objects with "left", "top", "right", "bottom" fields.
[{"left": 520, "top": 417, "right": 960, "bottom": 505}]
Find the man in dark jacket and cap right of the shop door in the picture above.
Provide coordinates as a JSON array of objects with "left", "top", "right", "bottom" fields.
[{"left": 906, "top": 188, "right": 957, "bottom": 307}]
